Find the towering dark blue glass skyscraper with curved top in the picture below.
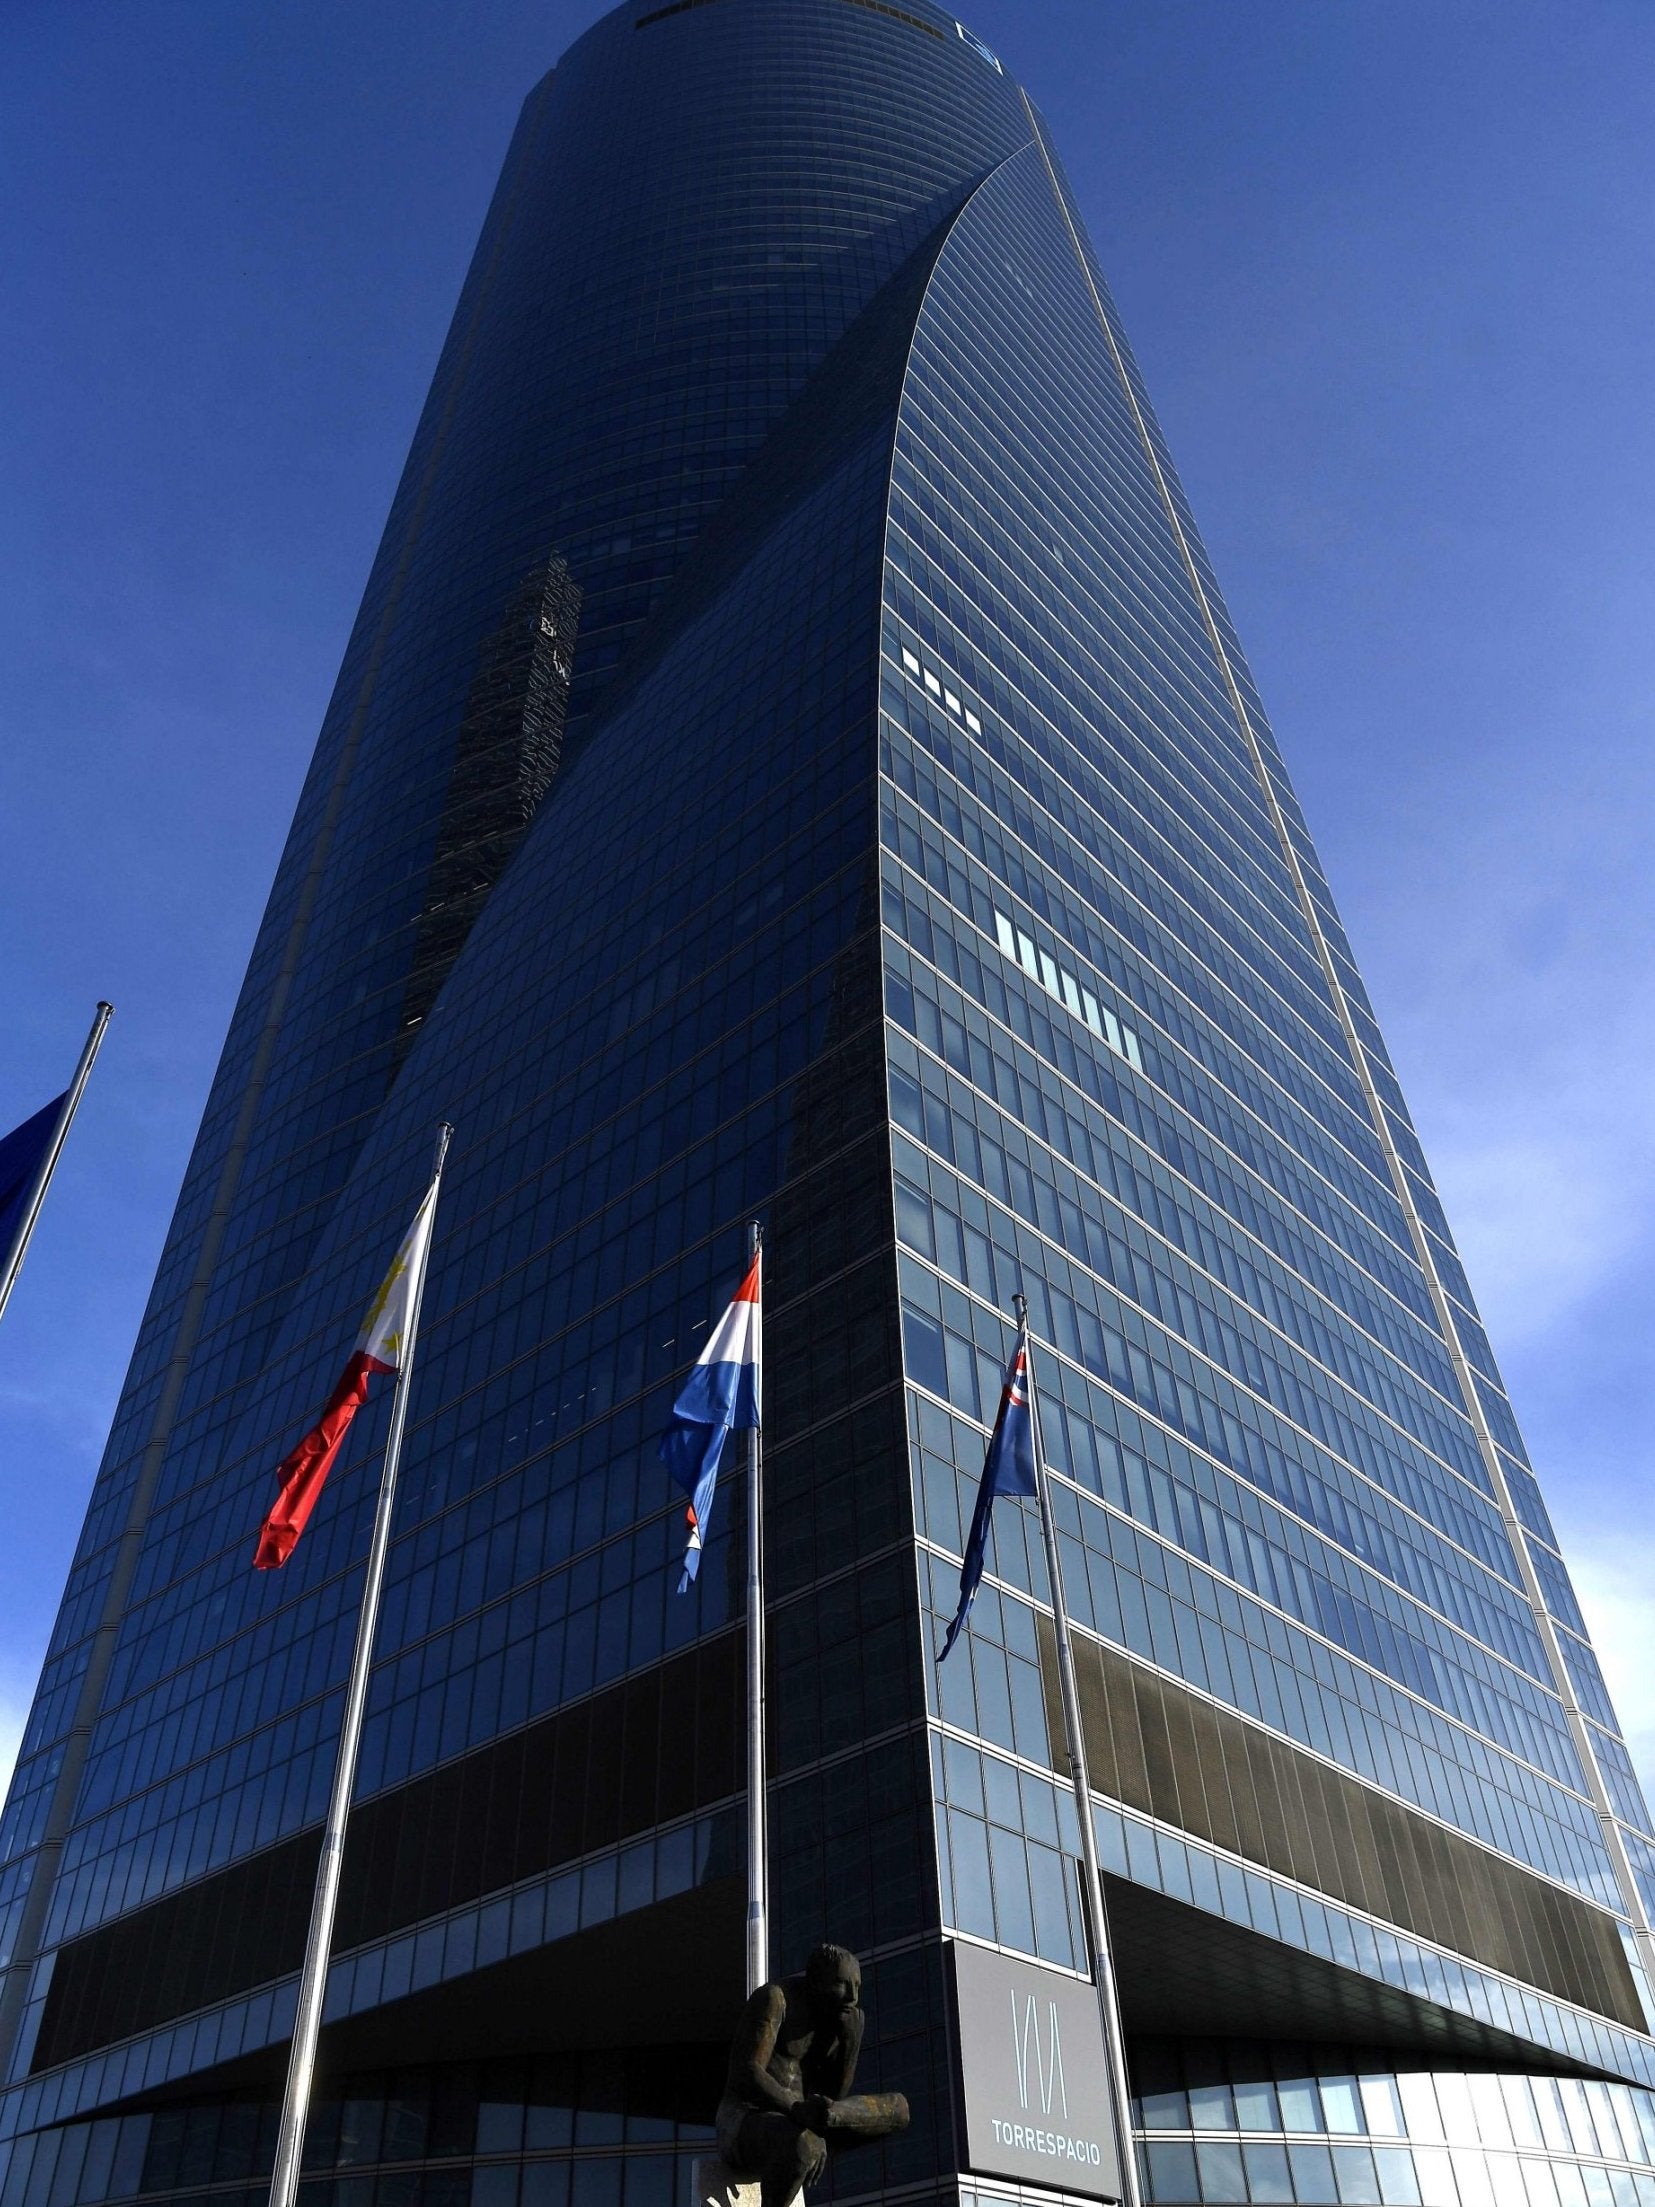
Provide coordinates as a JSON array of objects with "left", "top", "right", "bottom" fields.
[{"left": 0, "top": 0, "right": 1655, "bottom": 2207}]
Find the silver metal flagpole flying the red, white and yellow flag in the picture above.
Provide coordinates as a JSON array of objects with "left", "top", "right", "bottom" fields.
[{"left": 269, "top": 1121, "right": 455, "bottom": 2207}]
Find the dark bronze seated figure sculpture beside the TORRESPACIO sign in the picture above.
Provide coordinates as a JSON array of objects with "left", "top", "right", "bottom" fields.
[{"left": 717, "top": 1947, "right": 907, "bottom": 2207}]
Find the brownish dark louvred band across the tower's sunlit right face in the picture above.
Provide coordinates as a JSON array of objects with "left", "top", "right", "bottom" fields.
[{"left": 1037, "top": 1616, "right": 1644, "bottom": 2033}]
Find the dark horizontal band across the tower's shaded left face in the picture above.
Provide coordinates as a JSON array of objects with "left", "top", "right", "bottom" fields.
[{"left": 33, "top": 1629, "right": 746, "bottom": 2072}]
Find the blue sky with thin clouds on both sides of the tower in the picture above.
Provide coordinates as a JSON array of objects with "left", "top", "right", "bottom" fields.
[{"left": 0, "top": 0, "right": 1655, "bottom": 1777}]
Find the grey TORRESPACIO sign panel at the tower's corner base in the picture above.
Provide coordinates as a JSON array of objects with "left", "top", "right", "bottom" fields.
[{"left": 949, "top": 1940, "right": 1121, "bottom": 2200}]
